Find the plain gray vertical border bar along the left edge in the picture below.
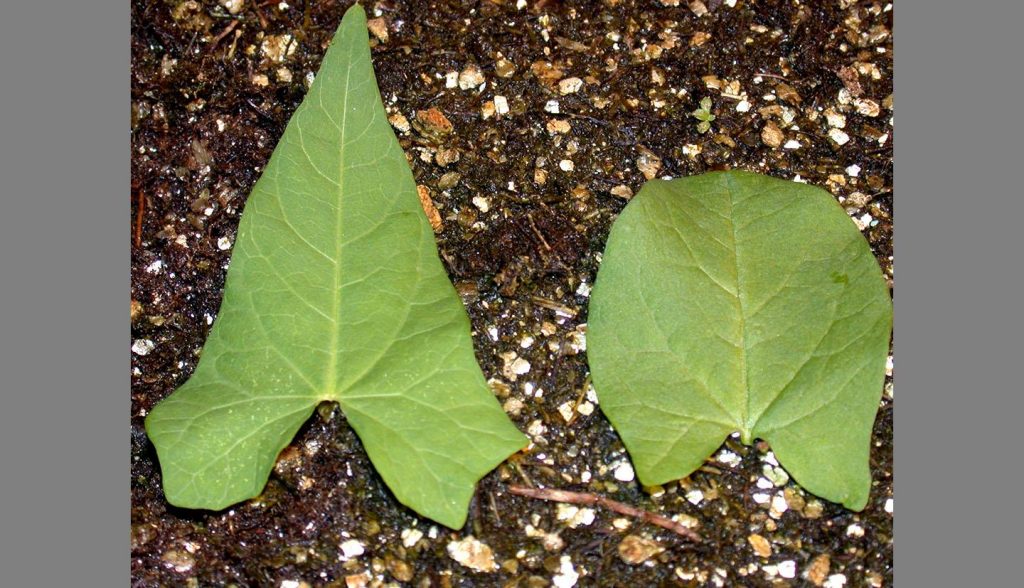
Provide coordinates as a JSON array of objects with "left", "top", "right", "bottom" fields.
[{"left": 0, "top": 2, "right": 130, "bottom": 586}]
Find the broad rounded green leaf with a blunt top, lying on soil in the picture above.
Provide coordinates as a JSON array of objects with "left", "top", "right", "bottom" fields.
[{"left": 588, "top": 171, "right": 892, "bottom": 510}]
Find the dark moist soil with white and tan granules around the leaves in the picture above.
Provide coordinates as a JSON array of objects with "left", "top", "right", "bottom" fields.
[{"left": 130, "top": 0, "right": 893, "bottom": 587}]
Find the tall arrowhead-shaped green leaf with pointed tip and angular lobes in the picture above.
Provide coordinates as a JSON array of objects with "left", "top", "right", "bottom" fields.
[{"left": 145, "top": 5, "right": 526, "bottom": 528}]
